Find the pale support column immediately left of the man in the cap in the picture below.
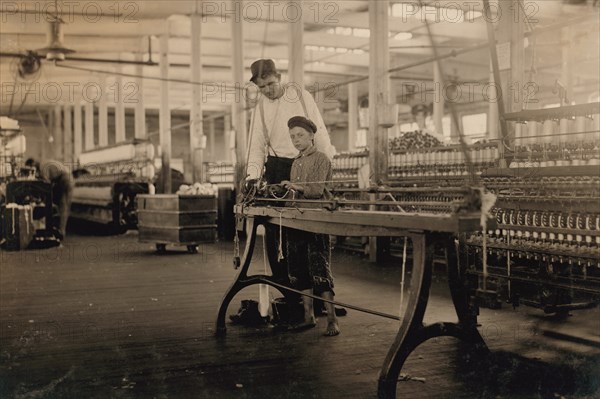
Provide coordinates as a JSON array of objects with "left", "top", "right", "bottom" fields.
[{"left": 231, "top": 0, "right": 248, "bottom": 192}]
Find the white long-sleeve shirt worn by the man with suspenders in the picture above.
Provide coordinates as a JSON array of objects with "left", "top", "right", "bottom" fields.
[{"left": 248, "top": 86, "right": 335, "bottom": 179}]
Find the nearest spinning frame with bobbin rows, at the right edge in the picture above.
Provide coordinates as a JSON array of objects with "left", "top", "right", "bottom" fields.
[{"left": 466, "top": 103, "right": 600, "bottom": 315}]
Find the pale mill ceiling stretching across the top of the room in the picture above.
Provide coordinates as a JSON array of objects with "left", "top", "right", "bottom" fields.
[{"left": 0, "top": 0, "right": 599, "bottom": 113}]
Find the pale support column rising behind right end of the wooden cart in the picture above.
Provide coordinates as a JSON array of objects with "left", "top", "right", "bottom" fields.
[{"left": 191, "top": 14, "right": 206, "bottom": 182}]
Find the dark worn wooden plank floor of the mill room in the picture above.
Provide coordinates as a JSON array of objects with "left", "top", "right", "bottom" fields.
[{"left": 0, "top": 228, "right": 600, "bottom": 399}]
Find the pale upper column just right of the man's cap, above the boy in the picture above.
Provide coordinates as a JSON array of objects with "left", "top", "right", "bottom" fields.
[{"left": 287, "top": 0, "right": 304, "bottom": 88}]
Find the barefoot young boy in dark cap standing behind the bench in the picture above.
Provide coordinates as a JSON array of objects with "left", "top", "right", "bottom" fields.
[{"left": 281, "top": 116, "right": 340, "bottom": 336}]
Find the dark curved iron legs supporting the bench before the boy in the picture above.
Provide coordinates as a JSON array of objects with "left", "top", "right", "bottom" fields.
[{"left": 216, "top": 216, "right": 488, "bottom": 399}]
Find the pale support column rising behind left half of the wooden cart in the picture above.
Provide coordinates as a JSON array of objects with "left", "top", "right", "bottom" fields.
[{"left": 158, "top": 20, "right": 171, "bottom": 194}]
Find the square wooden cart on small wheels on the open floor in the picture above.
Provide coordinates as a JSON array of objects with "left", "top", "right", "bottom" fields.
[{"left": 137, "top": 194, "right": 217, "bottom": 253}]
